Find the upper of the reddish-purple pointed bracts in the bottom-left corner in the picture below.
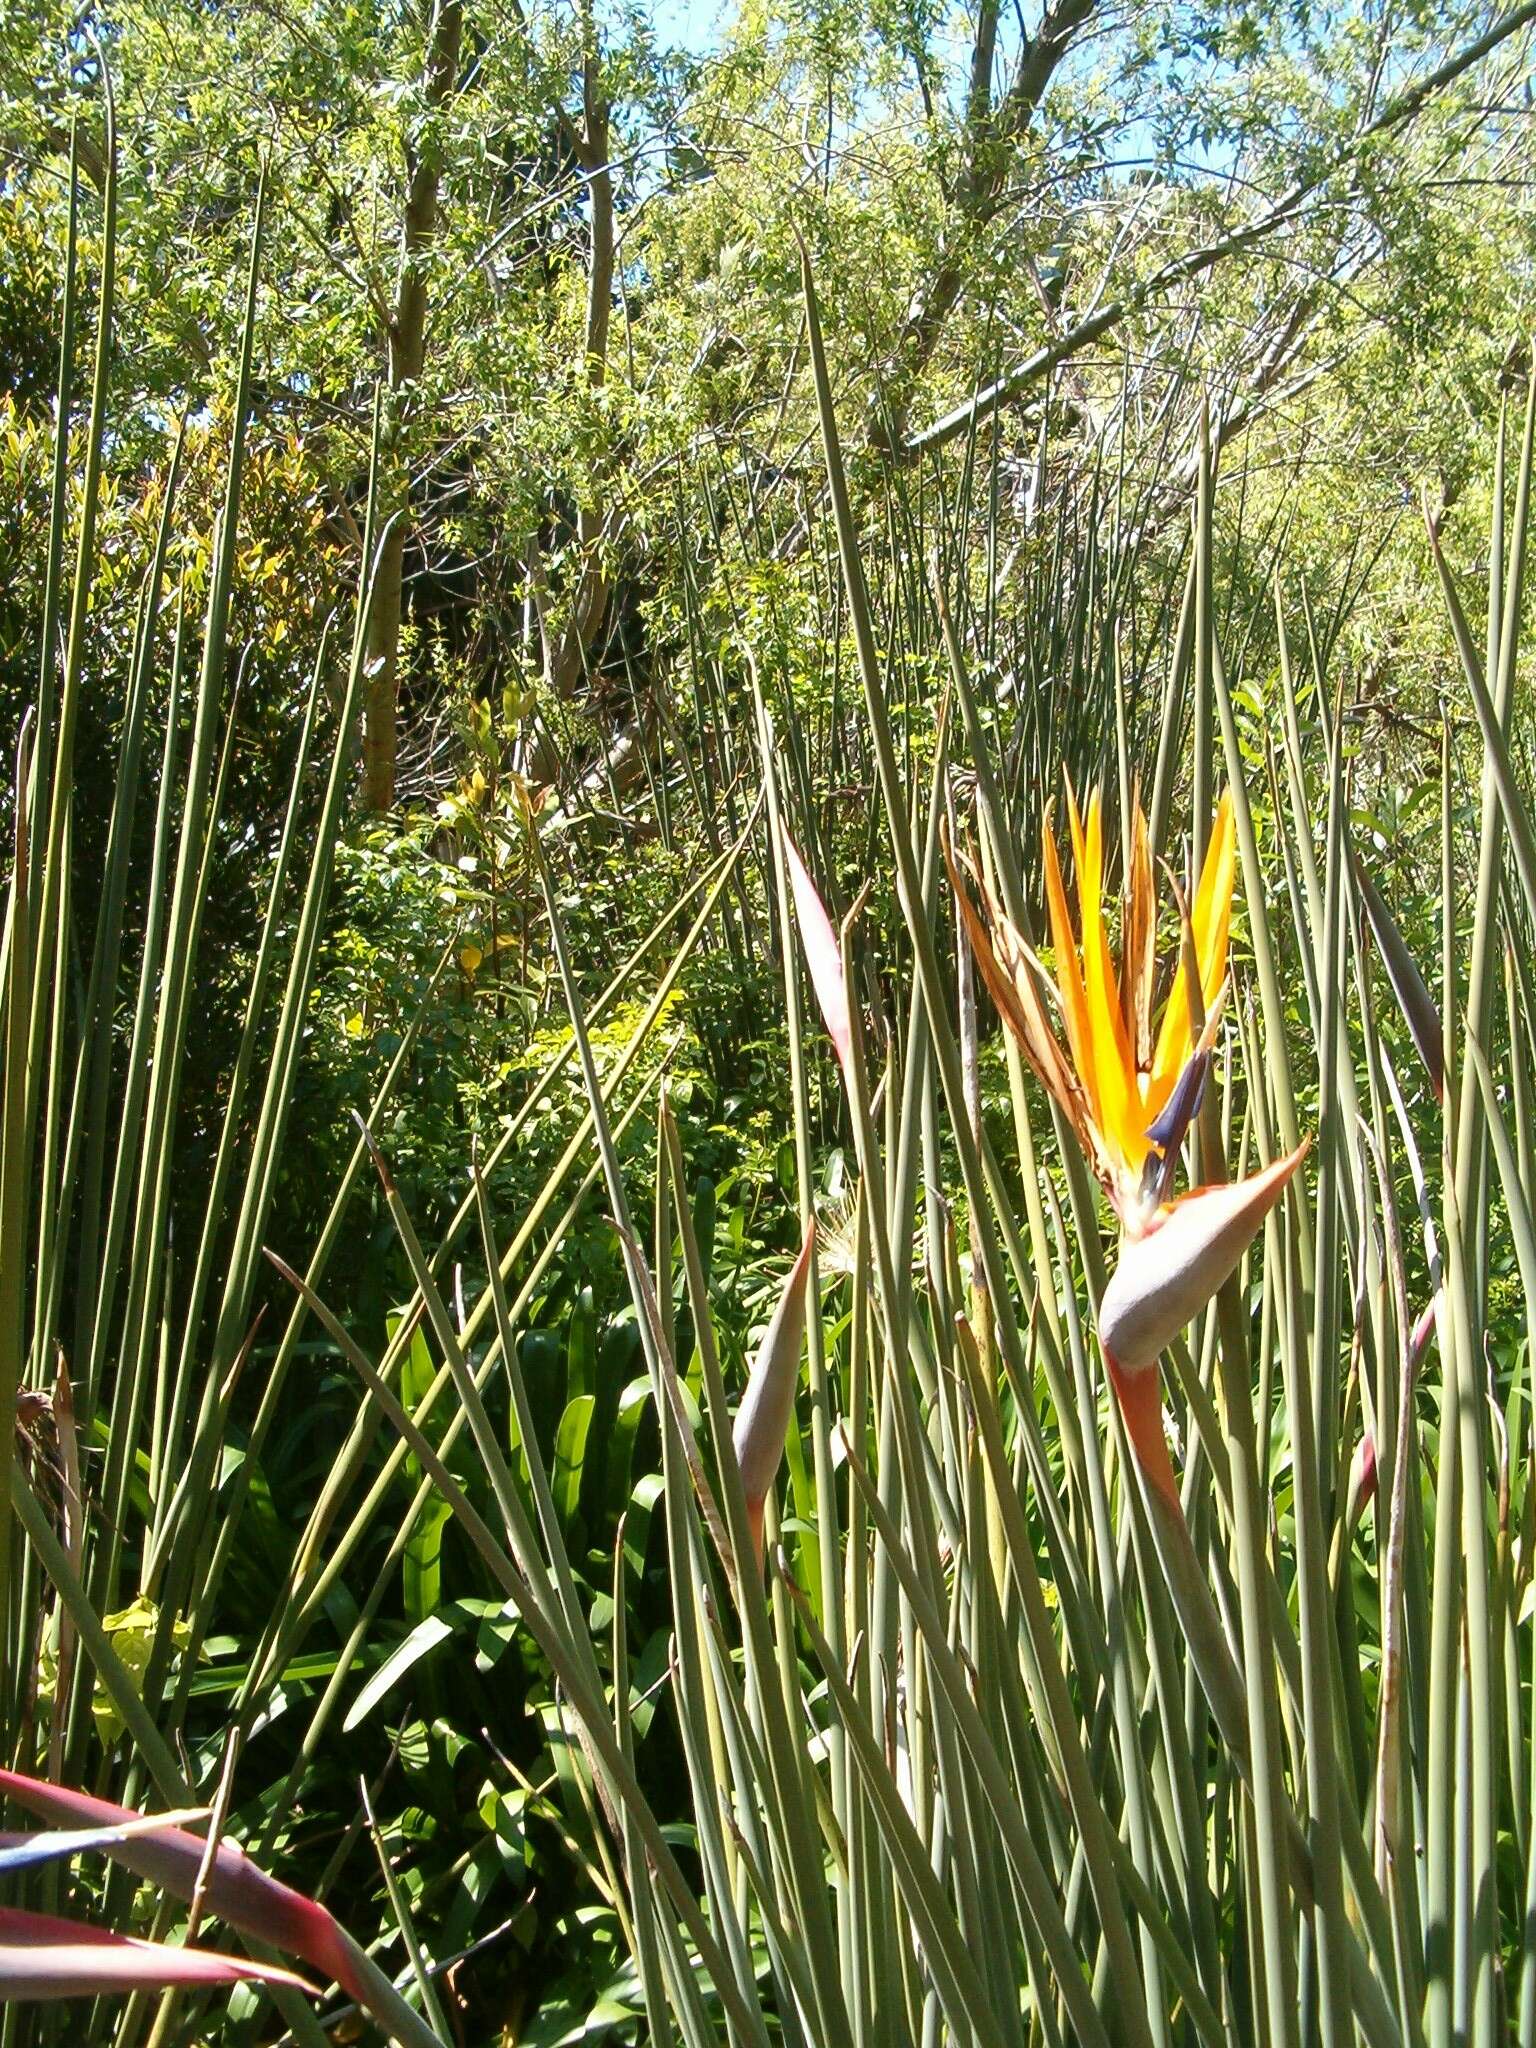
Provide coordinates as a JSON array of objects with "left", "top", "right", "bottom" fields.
[{"left": 0, "top": 1769, "right": 369, "bottom": 2003}]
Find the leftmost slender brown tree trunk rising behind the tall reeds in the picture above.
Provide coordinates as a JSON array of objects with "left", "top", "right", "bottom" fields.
[{"left": 362, "top": 0, "right": 463, "bottom": 811}]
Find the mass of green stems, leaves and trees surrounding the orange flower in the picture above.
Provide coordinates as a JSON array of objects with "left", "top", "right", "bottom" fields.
[{"left": 0, "top": 0, "right": 1536, "bottom": 2048}]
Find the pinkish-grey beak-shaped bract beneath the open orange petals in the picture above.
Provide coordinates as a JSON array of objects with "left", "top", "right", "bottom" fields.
[{"left": 1098, "top": 1141, "right": 1311, "bottom": 1372}]
